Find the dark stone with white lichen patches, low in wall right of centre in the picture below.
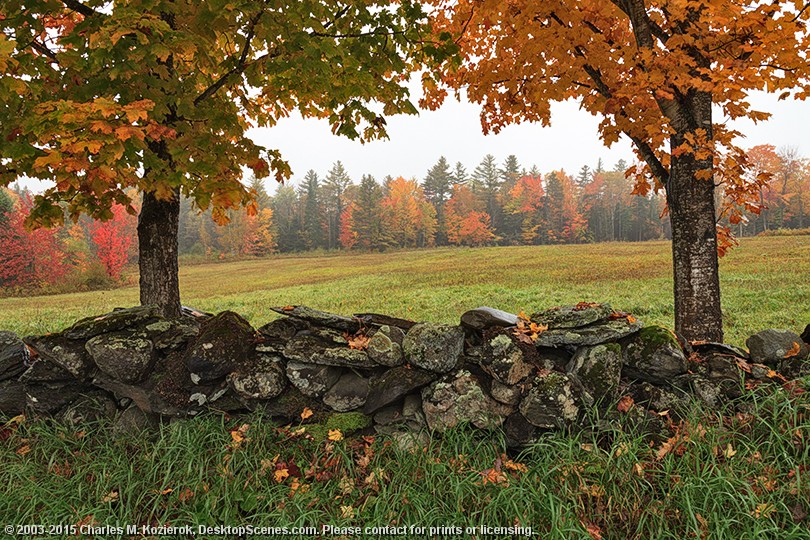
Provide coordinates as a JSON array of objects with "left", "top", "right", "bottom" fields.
[{"left": 518, "top": 371, "right": 580, "bottom": 429}]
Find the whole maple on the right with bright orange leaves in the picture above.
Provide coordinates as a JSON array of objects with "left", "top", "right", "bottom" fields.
[{"left": 423, "top": 0, "right": 810, "bottom": 341}]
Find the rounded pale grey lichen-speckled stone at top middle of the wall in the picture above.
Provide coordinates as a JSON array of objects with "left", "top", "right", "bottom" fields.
[{"left": 402, "top": 323, "right": 464, "bottom": 373}]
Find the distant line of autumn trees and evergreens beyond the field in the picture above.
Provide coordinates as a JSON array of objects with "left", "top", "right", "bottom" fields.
[{"left": 0, "top": 145, "right": 810, "bottom": 289}]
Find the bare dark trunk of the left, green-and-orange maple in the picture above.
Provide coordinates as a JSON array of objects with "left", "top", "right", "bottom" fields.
[{"left": 138, "top": 190, "right": 180, "bottom": 318}]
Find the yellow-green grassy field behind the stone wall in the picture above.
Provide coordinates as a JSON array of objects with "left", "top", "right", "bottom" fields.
[{"left": 0, "top": 236, "right": 810, "bottom": 344}]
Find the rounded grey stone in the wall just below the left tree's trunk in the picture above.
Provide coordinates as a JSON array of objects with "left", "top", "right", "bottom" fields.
[{"left": 85, "top": 331, "right": 155, "bottom": 383}]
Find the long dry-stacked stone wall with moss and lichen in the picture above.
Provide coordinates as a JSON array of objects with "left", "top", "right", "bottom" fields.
[{"left": 0, "top": 303, "right": 810, "bottom": 445}]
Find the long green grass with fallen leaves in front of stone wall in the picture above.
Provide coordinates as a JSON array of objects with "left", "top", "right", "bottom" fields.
[{"left": 0, "top": 380, "right": 810, "bottom": 539}]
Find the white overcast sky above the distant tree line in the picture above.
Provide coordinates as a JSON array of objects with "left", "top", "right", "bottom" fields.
[{"left": 12, "top": 89, "right": 810, "bottom": 192}]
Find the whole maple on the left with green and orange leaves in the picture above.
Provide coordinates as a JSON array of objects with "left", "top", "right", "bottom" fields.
[{"left": 0, "top": 0, "right": 441, "bottom": 316}]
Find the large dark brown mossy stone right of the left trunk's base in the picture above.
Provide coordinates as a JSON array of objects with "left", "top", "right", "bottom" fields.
[{"left": 184, "top": 311, "right": 256, "bottom": 383}]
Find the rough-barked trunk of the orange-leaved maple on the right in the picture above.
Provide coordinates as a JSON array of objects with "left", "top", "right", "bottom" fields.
[{"left": 667, "top": 95, "right": 723, "bottom": 342}]
